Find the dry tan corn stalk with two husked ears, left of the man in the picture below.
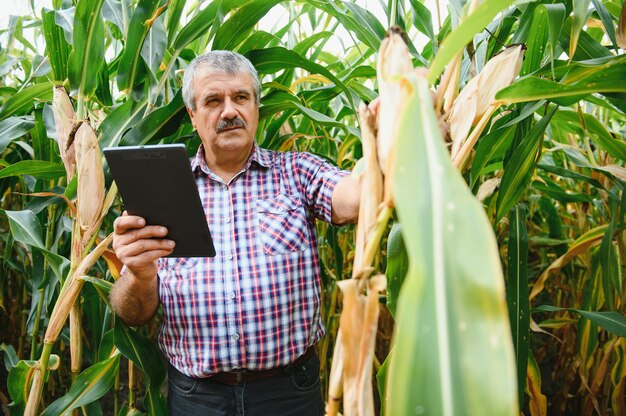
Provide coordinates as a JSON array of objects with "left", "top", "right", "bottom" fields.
[{"left": 25, "top": 87, "right": 117, "bottom": 416}]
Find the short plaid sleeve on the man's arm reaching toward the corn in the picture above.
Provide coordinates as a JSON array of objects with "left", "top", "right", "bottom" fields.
[{"left": 295, "top": 153, "right": 350, "bottom": 223}]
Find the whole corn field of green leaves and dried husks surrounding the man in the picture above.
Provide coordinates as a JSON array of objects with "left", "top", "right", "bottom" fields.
[{"left": 0, "top": 0, "right": 626, "bottom": 416}]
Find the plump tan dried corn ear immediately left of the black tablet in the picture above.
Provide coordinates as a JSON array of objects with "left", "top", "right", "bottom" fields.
[{"left": 74, "top": 122, "right": 104, "bottom": 232}]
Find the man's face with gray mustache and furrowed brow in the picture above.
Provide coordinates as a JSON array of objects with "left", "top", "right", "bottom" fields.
[{"left": 187, "top": 70, "right": 259, "bottom": 157}]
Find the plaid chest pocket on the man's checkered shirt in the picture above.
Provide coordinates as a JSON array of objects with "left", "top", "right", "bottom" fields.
[{"left": 256, "top": 195, "right": 310, "bottom": 256}]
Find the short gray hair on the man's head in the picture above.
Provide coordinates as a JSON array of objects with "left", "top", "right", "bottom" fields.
[{"left": 183, "top": 51, "right": 261, "bottom": 111}]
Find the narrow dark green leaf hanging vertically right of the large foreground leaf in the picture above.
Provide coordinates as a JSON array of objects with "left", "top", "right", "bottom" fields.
[{"left": 506, "top": 204, "right": 530, "bottom": 405}]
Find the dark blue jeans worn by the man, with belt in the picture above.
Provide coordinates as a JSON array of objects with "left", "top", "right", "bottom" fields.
[{"left": 168, "top": 357, "right": 324, "bottom": 416}]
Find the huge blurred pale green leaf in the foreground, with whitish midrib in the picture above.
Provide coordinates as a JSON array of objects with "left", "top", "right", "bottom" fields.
[{"left": 387, "top": 75, "right": 519, "bottom": 416}]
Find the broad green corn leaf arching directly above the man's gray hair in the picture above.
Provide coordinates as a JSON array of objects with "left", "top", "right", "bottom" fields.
[{"left": 212, "top": 0, "right": 283, "bottom": 50}]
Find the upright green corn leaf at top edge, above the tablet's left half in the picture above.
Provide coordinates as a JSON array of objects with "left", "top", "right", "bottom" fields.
[{"left": 117, "top": 0, "right": 161, "bottom": 91}]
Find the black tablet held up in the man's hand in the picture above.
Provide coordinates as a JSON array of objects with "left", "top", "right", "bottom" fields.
[{"left": 104, "top": 144, "right": 215, "bottom": 257}]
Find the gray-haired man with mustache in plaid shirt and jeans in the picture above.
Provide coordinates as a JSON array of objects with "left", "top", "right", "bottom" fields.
[{"left": 111, "top": 51, "right": 360, "bottom": 416}]
